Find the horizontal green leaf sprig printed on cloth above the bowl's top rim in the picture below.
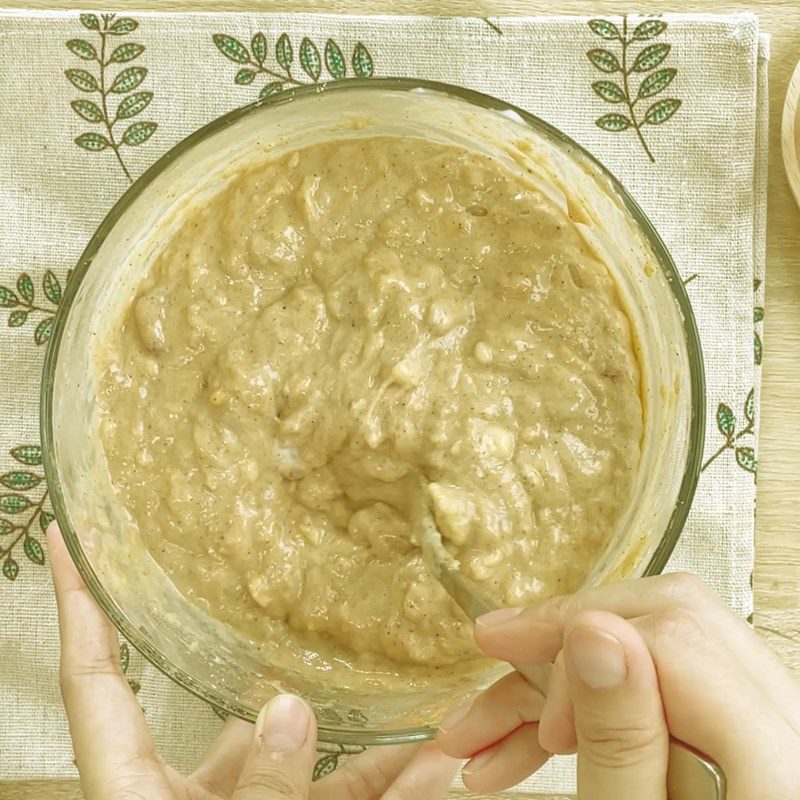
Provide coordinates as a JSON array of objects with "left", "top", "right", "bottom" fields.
[{"left": 211, "top": 31, "right": 375, "bottom": 99}]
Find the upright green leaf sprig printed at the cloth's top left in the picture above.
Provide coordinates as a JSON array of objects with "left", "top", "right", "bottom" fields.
[{"left": 65, "top": 14, "right": 158, "bottom": 181}]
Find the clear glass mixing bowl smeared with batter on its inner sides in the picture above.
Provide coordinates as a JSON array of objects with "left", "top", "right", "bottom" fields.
[{"left": 41, "top": 78, "right": 705, "bottom": 744}]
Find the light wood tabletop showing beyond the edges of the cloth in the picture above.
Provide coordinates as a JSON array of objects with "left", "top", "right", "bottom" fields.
[{"left": 0, "top": 0, "right": 800, "bottom": 800}]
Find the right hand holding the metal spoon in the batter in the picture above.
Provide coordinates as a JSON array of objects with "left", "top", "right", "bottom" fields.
[{"left": 439, "top": 575, "right": 800, "bottom": 800}]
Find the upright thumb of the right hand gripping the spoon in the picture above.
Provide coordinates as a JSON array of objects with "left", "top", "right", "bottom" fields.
[{"left": 564, "top": 611, "right": 669, "bottom": 800}]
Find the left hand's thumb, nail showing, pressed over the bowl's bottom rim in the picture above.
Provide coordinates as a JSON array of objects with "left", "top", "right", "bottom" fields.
[{"left": 231, "top": 694, "right": 317, "bottom": 800}]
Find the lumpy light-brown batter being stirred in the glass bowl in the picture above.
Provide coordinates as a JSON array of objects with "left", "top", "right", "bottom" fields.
[{"left": 101, "top": 137, "right": 642, "bottom": 670}]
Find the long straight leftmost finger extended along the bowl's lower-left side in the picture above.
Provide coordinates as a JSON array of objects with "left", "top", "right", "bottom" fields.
[{"left": 47, "top": 523, "right": 171, "bottom": 798}]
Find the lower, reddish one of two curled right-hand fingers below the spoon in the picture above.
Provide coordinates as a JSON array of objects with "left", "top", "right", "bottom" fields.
[{"left": 461, "top": 723, "right": 549, "bottom": 795}]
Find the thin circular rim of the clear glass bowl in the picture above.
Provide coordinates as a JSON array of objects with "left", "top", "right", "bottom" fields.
[{"left": 40, "top": 77, "right": 706, "bottom": 745}]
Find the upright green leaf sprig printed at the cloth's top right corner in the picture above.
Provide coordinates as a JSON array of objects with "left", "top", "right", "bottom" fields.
[{"left": 586, "top": 15, "right": 681, "bottom": 162}]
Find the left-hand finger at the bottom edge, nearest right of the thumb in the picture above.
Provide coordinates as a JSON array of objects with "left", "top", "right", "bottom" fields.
[{"left": 311, "top": 745, "right": 420, "bottom": 800}]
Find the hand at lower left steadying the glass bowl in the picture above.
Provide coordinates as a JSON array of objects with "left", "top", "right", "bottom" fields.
[{"left": 47, "top": 523, "right": 457, "bottom": 800}]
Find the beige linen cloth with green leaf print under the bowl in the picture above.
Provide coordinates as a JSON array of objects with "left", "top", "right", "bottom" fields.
[{"left": 0, "top": 11, "right": 768, "bottom": 792}]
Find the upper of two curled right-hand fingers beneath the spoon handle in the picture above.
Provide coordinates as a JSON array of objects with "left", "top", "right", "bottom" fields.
[{"left": 437, "top": 672, "right": 544, "bottom": 758}]
